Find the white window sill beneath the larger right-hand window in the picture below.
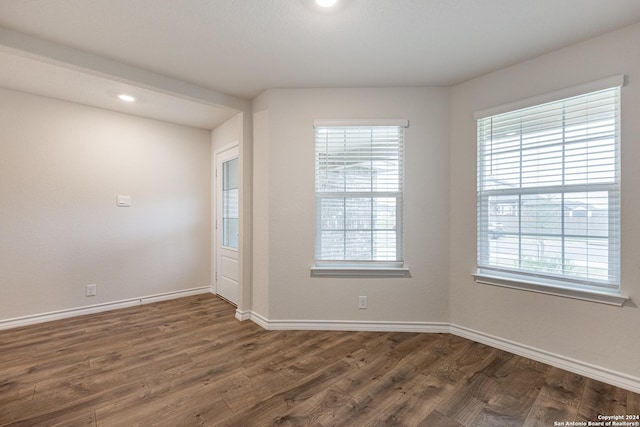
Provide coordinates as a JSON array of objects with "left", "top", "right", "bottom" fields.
[{"left": 472, "top": 272, "right": 629, "bottom": 307}]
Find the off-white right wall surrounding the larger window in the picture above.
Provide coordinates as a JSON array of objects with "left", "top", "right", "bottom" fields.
[{"left": 449, "top": 24, "right": 640, "bottom": 378}]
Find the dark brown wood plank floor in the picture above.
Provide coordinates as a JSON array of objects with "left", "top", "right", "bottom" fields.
[{"left": 0, "top": 295, "right": 640, "bottom": 427}]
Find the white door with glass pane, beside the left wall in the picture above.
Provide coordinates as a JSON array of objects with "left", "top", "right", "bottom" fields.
[{"left": 215, "top": 146, "right": 239, "bottom": 305}]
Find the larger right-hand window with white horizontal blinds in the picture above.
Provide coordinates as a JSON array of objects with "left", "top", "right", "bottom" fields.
[{"left": 476, "top": 79, "right": 620, "bottom": 300}]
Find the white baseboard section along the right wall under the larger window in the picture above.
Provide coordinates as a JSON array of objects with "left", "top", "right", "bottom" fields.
[{"left": 450, "top": 325, "right": 640, "bottom": 393}]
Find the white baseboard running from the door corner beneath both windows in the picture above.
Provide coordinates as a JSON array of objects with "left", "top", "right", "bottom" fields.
[{"left": 236, "top": 311, "right": 640, "bottom": 393}]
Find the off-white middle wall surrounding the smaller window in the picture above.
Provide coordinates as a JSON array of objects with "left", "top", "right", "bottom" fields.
[{"left": 253, "top": 88, "right": 449, "bottom": 322}]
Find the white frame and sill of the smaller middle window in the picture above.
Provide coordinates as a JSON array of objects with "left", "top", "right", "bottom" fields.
[{"left": 311, "top": 119, "right": 410, "bottom": 277}]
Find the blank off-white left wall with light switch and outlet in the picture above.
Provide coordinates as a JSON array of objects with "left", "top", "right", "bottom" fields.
[{"left": 0, "top": 89, "right": 211, "bottom": 320}]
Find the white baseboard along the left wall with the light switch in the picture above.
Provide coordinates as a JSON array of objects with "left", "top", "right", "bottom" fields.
[{"left": 0, "top": 286, "right": 211, "bottom": 330}]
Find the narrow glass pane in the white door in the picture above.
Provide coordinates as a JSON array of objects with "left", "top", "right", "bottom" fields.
[{"left": 222, "top": 158, "right": 238, "bottom": 249}]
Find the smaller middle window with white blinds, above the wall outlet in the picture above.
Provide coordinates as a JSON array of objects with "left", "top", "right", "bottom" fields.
[{"left": 315, "top": 123, "right": 404, "bottom": 276}]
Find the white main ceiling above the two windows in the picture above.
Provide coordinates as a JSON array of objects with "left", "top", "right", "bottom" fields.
[{"left": 0, "top": 0, "right": 640, "bottom": 128}]
